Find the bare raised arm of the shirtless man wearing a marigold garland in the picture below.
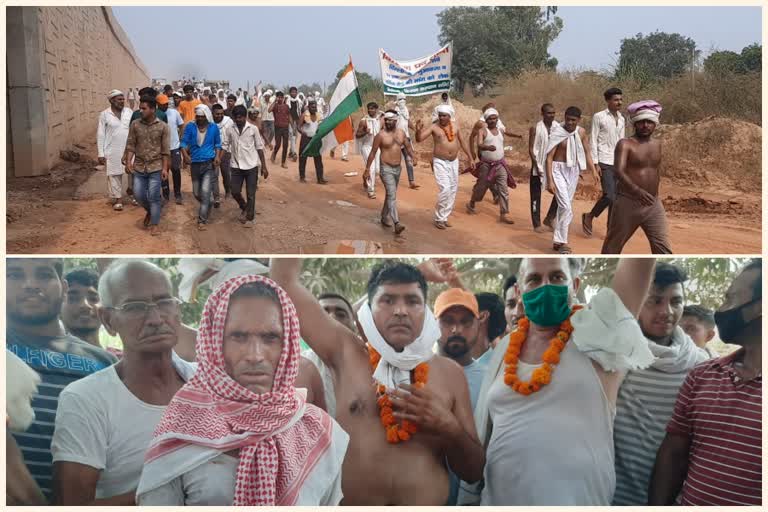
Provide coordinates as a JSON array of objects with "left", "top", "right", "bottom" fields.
[{"left": 269, "top": 258, "right": 359, "bottom": 369}]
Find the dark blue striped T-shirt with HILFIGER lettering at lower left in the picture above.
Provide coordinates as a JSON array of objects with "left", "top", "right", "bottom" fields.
[{"left": 6, "top": 329, "right": 117, "bottom": 499}]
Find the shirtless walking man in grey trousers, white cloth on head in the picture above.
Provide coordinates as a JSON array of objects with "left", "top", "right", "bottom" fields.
[{"left": 363, "top": 110, "right": 416, "bottom": 235}]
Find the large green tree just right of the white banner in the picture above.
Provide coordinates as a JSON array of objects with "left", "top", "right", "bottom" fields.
[{"left": 437, "top": 6, "right": 563, "bottom": 93}]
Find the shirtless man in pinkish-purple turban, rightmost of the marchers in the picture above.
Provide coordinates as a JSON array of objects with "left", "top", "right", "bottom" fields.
[{"left": 602, "top": 100, "right": 672, "bottom": 254}]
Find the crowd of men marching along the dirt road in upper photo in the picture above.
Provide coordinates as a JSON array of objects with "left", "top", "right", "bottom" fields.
[{"left": 97, "top": 84, "right": 671, "bottom": 254}]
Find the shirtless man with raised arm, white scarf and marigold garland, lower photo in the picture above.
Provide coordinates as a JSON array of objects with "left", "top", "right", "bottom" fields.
[{"left": 271, "top": 258, "right": 485, "bottom": 506}]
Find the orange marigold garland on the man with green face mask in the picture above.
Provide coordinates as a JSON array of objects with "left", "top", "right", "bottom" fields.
[{"left": 504, "top": 306, "right": 581, "bottom": 395}]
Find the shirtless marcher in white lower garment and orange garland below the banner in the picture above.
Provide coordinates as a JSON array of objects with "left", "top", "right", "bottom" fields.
[{"left": 416, "top": 105, "right": 473, "bottom": 229}]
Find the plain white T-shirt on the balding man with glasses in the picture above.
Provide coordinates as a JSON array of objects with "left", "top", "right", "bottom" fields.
[{"left": 51, "top": 353, "right": 197, "bottom": 499}]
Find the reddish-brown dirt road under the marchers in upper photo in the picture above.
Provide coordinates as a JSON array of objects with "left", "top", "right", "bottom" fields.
[{"left": 6, "top": 154, "right": 761, "bottom": 255}]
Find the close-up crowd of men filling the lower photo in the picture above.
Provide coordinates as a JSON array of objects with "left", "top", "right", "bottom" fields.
[{"left": 6, "top": 258, "right": 762, "bottom": 506}]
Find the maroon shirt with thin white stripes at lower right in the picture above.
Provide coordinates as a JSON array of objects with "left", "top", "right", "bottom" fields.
[{"left": 667, "top": 349, "right": 763, "bottom": 505}]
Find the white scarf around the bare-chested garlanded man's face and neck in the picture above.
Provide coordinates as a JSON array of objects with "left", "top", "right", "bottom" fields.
[{"left": 357, "top": 302, "right": 440, "bottom": 389}]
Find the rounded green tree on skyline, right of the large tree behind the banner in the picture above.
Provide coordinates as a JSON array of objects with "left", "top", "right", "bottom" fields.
[{"left": 616, "top": 31, "right": 701, "bottom": 85}]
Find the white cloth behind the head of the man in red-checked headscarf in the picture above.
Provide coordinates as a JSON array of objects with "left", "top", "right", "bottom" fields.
[{"left": 179, "top": 258, "right": 269, "bottom": 302}]
